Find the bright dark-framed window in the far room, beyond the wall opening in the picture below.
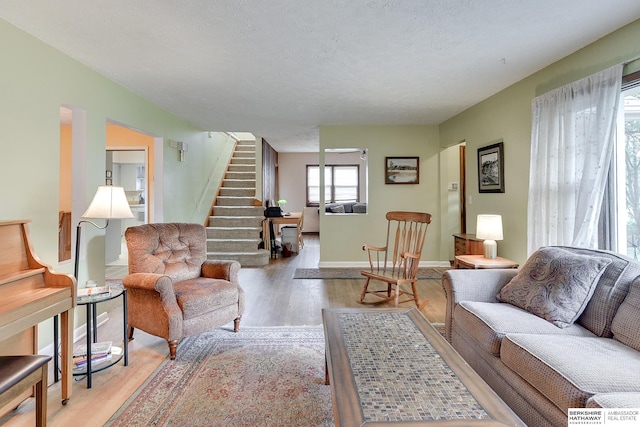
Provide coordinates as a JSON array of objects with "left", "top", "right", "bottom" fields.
[{"left": 307, "top": 165, "right": 360, "bottom": 206}]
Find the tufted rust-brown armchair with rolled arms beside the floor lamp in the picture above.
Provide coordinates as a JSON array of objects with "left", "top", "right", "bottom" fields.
[{"left": 123, "top": 223, "right": 244, "bottom": 360}]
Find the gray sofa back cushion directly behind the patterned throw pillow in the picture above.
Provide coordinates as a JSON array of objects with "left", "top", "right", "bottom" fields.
[{"left": 558, "top": 246, "right": 640, "bottom": 338}]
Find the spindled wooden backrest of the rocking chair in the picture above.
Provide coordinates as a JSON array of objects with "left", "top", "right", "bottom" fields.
[{"left": 384, "top": 211, "right": 431, "bottom": 278}]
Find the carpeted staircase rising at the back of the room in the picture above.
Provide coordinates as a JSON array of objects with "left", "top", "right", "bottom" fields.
[{"left": 207, "top": 141, "right": 269, "bottom": 267}]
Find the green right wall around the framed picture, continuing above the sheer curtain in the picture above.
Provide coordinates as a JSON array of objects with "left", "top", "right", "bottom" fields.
[{"left": 440, "top": 21, "right": 640, "bottom": 263}]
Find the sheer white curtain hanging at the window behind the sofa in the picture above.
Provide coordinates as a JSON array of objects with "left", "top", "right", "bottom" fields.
[{"left": 527, "top": 64, "right": 622, "bottom": 254}]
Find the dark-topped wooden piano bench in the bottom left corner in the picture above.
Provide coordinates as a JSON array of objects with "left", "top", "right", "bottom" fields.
[{"left": 0, "top": 355, "right": 51, "bottom": 427}]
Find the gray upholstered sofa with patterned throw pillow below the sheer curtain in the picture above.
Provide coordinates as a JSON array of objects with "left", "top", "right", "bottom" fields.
[{"left": 442, "top": 247, "right": 640, "bottom": 427}]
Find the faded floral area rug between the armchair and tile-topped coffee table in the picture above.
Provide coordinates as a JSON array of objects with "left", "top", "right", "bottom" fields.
[{"left": 106, "top": 327, "right": 334, "bottom": 427}]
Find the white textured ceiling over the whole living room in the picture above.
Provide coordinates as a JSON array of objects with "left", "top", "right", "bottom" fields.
[{"left": 0, "top": 0, "right": 640, "bottom": 152}]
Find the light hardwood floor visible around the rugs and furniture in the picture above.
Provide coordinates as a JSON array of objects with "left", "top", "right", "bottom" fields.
[{"left": 0, "top": 235, "right": 445, "bottom": 427}]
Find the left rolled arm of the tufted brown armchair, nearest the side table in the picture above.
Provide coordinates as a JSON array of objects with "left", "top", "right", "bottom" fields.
[{"left": 122, "top": 273, "right": 182, "bottom": 341}]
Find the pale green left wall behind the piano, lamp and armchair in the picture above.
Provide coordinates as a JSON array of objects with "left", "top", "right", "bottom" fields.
[{"left": 0, "top": 20, "right": 233, "bottom": 350}]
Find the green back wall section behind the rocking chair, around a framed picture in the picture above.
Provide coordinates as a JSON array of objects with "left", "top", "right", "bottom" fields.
[{"left": 320, "top": 126, "right": 442, "bottom": 267}]
